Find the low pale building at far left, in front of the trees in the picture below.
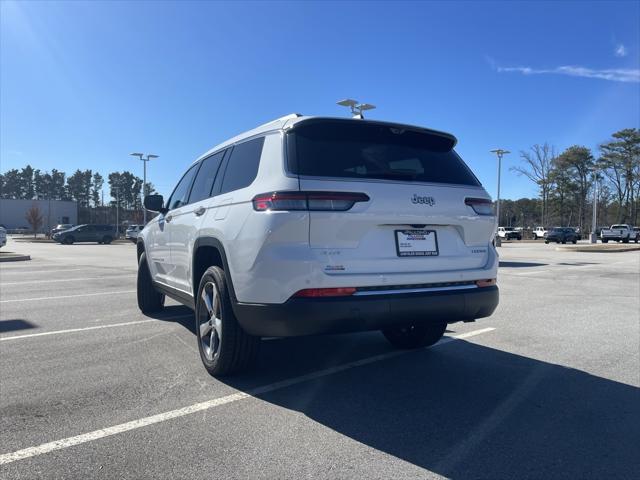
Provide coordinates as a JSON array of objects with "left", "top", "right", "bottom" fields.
[{"left": 0, "top": 198, "right": 78, "bottom": 232}]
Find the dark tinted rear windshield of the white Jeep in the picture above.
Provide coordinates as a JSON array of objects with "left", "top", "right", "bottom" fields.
[{"left": 288, "top": 120, "right": 480, "bottom": 186}]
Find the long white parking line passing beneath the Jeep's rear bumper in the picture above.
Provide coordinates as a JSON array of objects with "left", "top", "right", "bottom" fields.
[{"left": 0, "top": 328, "right": 495, "bottom": 465}]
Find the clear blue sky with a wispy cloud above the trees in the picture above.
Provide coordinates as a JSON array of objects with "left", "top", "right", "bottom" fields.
[{"left": 0, "top": 0, "right": 640, "bottom": 198}]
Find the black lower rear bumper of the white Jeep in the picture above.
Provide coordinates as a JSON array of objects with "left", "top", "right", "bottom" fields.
[{"left": 233, "top": 286, "right": 499, "bottom": 337}]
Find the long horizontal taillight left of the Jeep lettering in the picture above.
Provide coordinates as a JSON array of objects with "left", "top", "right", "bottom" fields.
[{"left": 253, "top": 192, "right": 369, "bottom": 212}]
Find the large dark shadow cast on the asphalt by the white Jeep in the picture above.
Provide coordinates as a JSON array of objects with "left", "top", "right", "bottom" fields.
[{"left": 222, "top": 334, "right": 640, "bottom": 479}]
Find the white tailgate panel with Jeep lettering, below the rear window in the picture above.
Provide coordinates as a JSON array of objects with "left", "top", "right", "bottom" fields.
[{"left": 300, "top": 179, "right": 495, "bottom": 275}]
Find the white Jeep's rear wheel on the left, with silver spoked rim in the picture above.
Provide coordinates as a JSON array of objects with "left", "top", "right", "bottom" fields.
[{"left": 196, "top": 267, "right": 260, "bottom": 376}]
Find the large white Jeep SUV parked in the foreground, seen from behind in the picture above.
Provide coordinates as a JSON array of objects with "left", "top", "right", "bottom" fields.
[{"left": 137, "top": 114, "right": 498, "bottom": 375}]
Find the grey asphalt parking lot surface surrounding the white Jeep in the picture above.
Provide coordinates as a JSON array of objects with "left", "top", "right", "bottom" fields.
[{"left": 0, "top": 241, "right": 640, "bottom": 479}]
